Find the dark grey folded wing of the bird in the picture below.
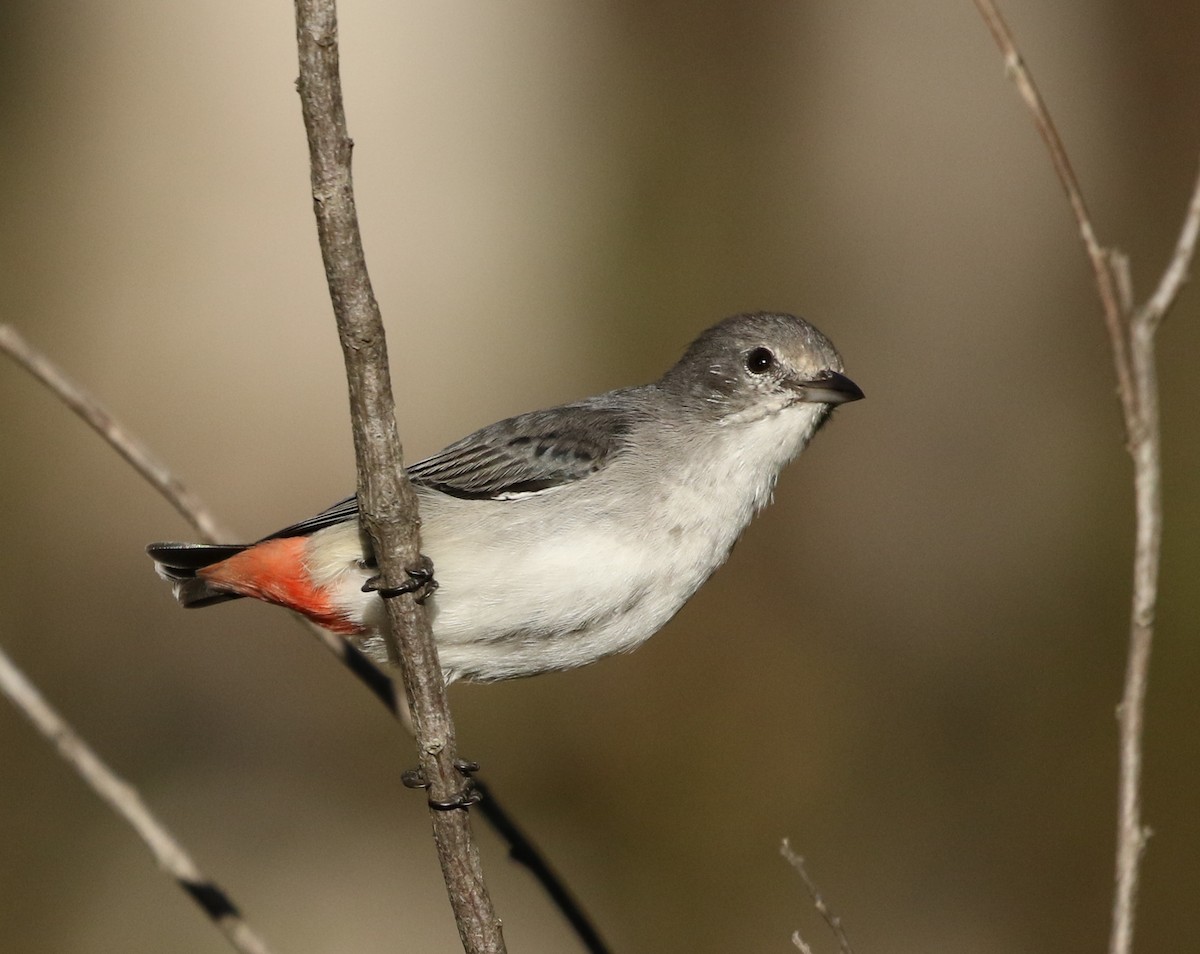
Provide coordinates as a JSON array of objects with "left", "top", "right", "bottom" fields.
[{"left": 408, "top": 395, "right": 632, "bottom": 500}]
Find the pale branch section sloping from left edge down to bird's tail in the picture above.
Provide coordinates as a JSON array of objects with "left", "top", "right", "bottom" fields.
[{"left": 0, "top": 324, "right": 232, "bottom": 544}]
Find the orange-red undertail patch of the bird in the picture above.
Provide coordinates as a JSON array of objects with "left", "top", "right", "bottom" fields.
[{"left": 197, "top": 536, "right": 362, "bottom": 635}]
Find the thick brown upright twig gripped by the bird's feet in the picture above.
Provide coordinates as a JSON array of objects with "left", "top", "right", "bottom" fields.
[{"left": 295, "top": 0, "right": 504, "bottom": 952}]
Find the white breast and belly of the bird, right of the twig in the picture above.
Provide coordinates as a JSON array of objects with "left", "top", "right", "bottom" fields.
[{"left": 388, "top": 404, "right": 821, "bottom": 680}]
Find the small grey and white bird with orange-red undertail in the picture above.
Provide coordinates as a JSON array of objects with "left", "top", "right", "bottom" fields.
[{"left": 148, "top": 313, "right": 863, "bottom": 683}]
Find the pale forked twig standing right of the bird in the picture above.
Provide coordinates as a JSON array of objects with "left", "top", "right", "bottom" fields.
[{"left": 976, "top": 0, "right": 1200, "bottom": 954}]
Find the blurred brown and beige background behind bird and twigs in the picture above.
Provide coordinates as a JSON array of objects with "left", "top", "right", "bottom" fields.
[{"left": 0, "top": 0, "right": 1200, "bottom": 954}]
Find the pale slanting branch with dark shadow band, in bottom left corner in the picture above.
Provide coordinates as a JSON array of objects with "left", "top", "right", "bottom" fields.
[{"left": 0, "top": 650, "right": 270, "bottom": 954}]
